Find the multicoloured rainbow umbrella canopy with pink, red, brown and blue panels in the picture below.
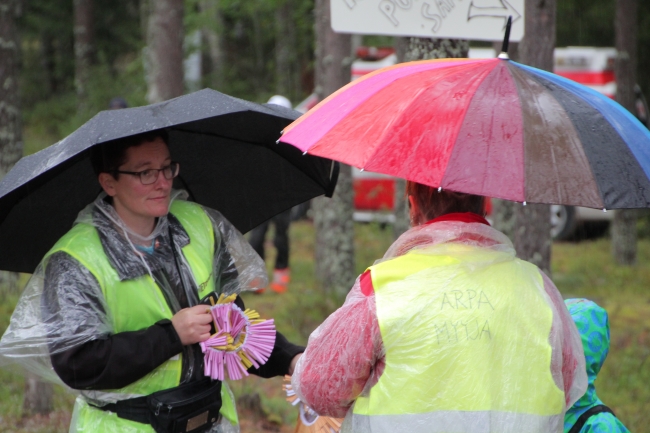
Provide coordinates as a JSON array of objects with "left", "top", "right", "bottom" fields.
[{"left": 281, "top": 59, "right": 650, "bottom": 209}]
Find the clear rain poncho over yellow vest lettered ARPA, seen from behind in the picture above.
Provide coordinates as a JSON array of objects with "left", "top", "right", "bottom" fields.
[{"left": 292, "top": 221, "right": 587, "bottom": 433}]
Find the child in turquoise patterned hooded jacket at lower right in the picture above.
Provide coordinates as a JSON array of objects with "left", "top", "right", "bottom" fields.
[{"left": 564, "top": 299, "right": 629, "bottom": 433}]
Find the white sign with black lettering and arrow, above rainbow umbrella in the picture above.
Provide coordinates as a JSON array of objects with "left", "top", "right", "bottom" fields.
[{"left": 330, "top": 0, "right": 524, "bottom": 42}]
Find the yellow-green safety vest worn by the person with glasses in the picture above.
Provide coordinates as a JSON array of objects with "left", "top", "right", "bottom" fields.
[{"left": 45, "top": 200, "right": 238, "bottom": 432}]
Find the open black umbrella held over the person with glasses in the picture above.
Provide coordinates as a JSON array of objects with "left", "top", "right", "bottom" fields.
[{"left": 0, "top": 89, "right": 338, "bottom": 272}]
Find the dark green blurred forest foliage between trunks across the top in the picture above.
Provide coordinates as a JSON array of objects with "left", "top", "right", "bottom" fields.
[{"left": 19, "top": 0, "right": 650, "bottom": 154}]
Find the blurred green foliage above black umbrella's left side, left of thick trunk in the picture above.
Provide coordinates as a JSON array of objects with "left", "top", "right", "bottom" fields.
[{"left": 20, "top": 0, "right": 146, "bottom": 154}]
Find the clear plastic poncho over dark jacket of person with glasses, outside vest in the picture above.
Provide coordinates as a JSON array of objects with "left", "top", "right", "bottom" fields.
[{"left": 0, "top": 191, "right": 267, "bottom": 431}]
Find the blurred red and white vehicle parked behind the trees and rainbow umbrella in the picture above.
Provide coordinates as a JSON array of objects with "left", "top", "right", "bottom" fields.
[{"left": 296, "top": 47, "right": 649, "bottom": 240}]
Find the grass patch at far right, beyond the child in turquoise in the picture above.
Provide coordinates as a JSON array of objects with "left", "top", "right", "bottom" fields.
[{"left": 552, "top": 239, "right": 650, "bottom": 426}]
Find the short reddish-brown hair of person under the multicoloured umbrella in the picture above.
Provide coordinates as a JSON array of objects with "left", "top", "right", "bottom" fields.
[{"left": 406, "top": 181, "right": 485, "bottom": 221}]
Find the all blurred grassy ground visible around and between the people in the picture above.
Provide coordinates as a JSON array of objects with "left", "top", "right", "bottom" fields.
[{"left": 0, "top": 221, "right": 650, "bottom": 433}]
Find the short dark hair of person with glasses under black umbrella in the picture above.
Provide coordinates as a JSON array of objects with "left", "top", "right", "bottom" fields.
[{"left": 90, "top": 129, "right": 169, "bottom": 179}]
